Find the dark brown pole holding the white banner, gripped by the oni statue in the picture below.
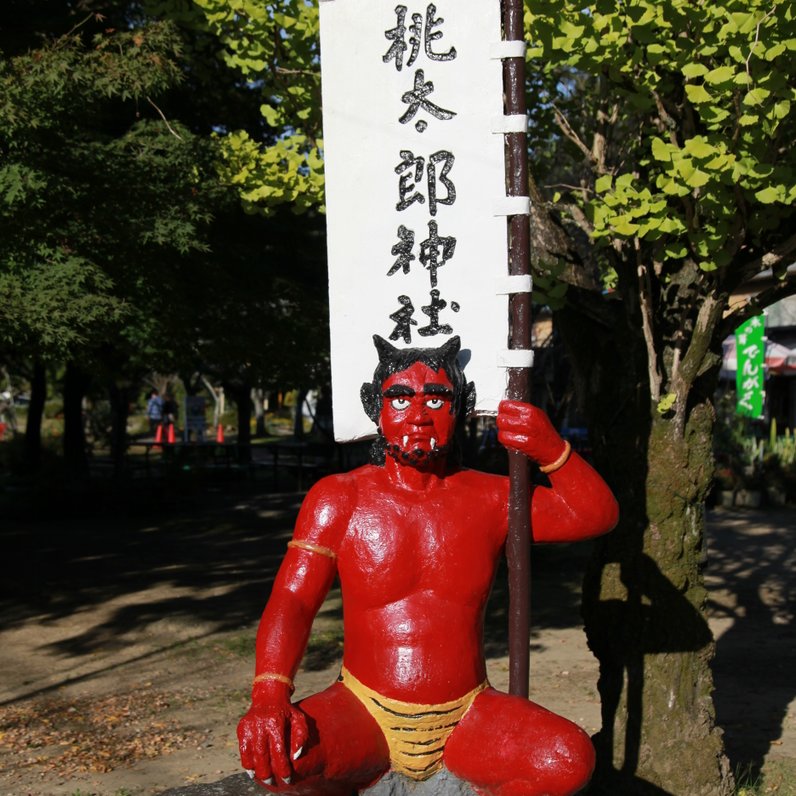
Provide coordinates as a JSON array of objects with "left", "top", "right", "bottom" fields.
[{"left": 503, "top": 0, "right": 531, "bottom": 698}]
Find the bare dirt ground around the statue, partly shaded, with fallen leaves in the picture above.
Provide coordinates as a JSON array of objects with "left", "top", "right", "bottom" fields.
[{"left": 0, "top": 494, "right": 796, "bottom": 796}]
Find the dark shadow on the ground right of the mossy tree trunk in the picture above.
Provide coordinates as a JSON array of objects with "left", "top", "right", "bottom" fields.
[{"left": 707, "top": 509, "right": 796, "bottom": 781}]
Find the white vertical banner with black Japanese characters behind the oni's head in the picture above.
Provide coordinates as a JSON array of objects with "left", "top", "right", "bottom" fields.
[{"left": 320, "top": 0, "right": 506, "bottom": 441}]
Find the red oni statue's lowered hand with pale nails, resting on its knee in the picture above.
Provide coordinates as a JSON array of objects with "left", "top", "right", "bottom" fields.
[{"left": 238, "top": 700, "right": 308, "bottom": 788}]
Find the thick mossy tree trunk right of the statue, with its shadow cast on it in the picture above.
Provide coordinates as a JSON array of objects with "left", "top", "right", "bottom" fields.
[{"left": 561, "top": 312, "right": 733, "bottom": 796}]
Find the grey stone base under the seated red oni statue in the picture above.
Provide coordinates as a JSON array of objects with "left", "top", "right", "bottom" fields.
[{"left": 159, "top": 769, "right": 476, "bottom": 796}]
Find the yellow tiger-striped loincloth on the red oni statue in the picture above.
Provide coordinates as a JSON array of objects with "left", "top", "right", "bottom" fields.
[{"left": 340, "top": 667, "right": 489, "bottom": 780}]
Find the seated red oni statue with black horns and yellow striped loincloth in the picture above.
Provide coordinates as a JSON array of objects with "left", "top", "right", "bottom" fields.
[{"left": 238, "top": 337, "right": 618, "bottom": 796}]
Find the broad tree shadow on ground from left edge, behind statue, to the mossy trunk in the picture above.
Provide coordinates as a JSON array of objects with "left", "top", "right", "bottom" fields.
[{"left": 0, "top": 472, "right": 588, "bottom": 704}]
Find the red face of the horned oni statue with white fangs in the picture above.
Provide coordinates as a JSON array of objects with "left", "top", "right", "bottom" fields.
[{"left": 380, "top": 362, "right": 456, "bottom": 464}]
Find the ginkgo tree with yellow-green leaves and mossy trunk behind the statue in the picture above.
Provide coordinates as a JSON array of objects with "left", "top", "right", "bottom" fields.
[{"left": 194, "top": 0, "right": 796, "bottom": 796}]
